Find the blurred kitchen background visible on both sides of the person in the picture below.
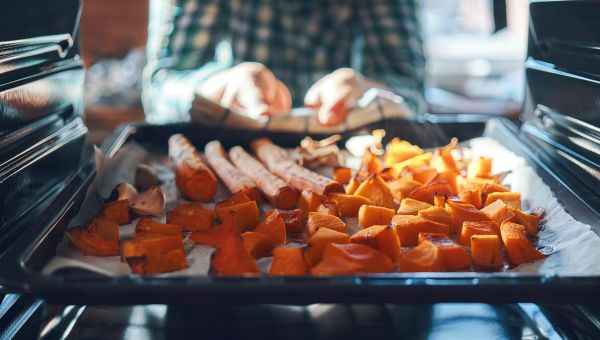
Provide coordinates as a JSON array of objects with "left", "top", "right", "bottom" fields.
[{"left": 81, "top": 0, "right": 528, "bottom": 143}]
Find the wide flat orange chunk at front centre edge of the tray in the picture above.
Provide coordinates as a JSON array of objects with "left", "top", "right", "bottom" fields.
[{"left": 323, "top": 243, "right": 394, "bottom": 273}]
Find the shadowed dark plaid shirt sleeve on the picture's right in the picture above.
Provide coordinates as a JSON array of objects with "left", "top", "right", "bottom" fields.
[{"left": 356, "top": 0, "right": 426, "bottom": 113}]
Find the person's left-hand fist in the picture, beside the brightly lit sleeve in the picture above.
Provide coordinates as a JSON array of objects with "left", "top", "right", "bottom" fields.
[{"left": 199, "top": 62, "right": 292, "bottom": 118}]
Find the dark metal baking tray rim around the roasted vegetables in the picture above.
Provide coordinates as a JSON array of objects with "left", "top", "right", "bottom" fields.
[{"left": 0, "top": 115, "right": 600, "bottom": 304}]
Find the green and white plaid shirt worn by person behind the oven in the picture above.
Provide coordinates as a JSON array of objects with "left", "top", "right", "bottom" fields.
[{"left": 143, "top": 0, "right": 425, "bottom": 123}]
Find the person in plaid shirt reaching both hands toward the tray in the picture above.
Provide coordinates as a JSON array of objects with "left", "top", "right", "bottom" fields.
[{"left": 143, "top": 0, "right": 425, "bottom": 125}]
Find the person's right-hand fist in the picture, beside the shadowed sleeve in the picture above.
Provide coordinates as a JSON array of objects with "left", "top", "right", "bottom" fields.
[{"left": 304, "top": 68, "right": 385, "bottom": 126}]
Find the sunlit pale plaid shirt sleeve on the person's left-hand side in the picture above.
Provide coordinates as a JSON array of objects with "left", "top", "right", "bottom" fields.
[{"left": 142, "top": 0, "right": 231, "bottom": 123}]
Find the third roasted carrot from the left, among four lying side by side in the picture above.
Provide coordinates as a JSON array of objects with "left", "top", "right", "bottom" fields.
[{"left": 229, "top": 146, "right": 298, "bottom": 209}]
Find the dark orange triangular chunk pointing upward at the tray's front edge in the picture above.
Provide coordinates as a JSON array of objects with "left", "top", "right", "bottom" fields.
[{"left": 210, "top": 235, "right": 260, "bottom": 276}]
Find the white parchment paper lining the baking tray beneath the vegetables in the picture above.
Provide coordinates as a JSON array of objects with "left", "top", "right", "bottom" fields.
[{"left": 43, "top": 137, "right": 600, "bottom": 277}]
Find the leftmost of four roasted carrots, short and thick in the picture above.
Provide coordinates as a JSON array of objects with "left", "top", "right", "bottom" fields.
[{"left": 169, "top": 134, "right": 217, "bottom": 201}]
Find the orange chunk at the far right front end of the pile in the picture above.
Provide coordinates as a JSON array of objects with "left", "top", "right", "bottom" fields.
[{"left": 500, "top": 221, "right": 544, "bottom": 264}]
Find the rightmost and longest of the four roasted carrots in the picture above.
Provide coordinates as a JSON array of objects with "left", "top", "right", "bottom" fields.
[{"left": 252, "top": 138, "right": 344, "bottom": 195}]
